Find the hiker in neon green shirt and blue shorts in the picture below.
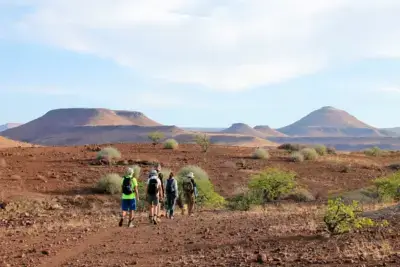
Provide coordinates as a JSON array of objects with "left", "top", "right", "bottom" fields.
[{"left": 119, "top": 168, "right": 139, "bottom": 227}]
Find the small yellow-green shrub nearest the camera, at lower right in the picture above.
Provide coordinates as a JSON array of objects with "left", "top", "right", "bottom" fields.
[{"left": 324, "top": 198, "right": 375, "bottom": 234}]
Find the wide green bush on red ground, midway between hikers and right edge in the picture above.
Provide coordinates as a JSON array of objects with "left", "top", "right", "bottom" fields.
[{"left": 249, "top": 168, "right": 296, "bottom": 203}]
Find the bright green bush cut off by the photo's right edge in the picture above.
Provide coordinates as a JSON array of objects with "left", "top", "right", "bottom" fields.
[{"left": 373, "top": 172, "right": 400, "bottom": 202}]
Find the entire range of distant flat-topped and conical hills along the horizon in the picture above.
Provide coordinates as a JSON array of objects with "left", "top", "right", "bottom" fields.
[{"left": 0, "top": 107, "right": 400, "bottom": 150}]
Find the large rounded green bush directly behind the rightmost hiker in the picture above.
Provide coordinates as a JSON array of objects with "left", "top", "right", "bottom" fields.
[{"left": 176, "top": 165, "right": 225, "bottom": 208}]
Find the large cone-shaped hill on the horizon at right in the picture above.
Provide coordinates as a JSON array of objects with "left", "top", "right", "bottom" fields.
[{"left": 277, "top": 107, "right": 385, "bottom": 137}]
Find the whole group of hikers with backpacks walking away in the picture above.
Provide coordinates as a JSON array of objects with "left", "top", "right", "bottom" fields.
[{"left": 119, "top": 165, "right": 197, "bottom": 227}]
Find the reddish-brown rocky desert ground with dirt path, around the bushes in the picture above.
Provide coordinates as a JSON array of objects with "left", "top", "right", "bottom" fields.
[{"left": 0, "top": 144, "right": 400, "bottom": 267}]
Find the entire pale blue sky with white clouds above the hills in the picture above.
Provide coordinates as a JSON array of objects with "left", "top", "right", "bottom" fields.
[{"left": 0, "top": 0, "right": 400, "bottom": 128}]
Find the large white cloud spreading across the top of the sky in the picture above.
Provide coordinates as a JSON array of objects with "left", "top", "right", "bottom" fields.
[{"left": 0, "top": 0, "right": 400, "bottom": 91}]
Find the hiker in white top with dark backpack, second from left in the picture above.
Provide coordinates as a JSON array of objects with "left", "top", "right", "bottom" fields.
[{"left": 146, "top": 170, "right": 164, "bottom": 224}]
